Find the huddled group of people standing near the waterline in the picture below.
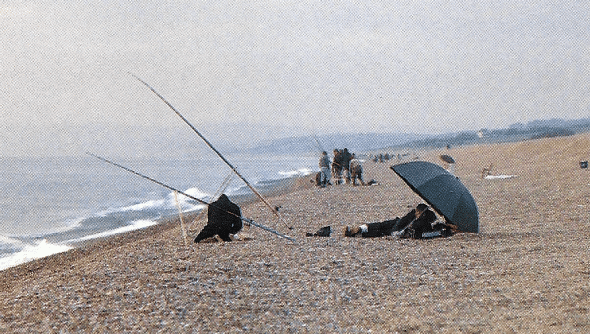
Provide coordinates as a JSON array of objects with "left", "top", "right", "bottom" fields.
[{"left": 316, "top": 148, "right": 365, "bottom": 187}]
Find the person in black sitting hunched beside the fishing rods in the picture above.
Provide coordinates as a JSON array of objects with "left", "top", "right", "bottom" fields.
[{"left": 195, "top": 194, "right": 242, "bottom": 243}]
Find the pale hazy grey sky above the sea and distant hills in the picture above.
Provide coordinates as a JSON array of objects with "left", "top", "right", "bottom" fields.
[{"left": 0, "top": 0, "right": 590, "bottom": 156}]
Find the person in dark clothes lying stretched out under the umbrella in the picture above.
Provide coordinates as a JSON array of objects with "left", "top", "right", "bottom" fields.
[{"left": 344, "top": 203, "right": 444, "bottom": 239}]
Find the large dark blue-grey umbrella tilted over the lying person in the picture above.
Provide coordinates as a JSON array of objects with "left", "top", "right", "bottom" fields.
[{"left": 391, "top": 161, "right": 479, "bottom": 233}]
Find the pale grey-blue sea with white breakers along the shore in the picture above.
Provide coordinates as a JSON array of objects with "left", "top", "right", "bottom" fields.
[{"left": 0, "top": 153, "right": 319, "bottom": 270}]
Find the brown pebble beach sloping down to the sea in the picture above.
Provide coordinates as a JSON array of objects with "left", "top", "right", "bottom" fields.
[{"left": 0, "top": 134, "right": 590, "bottom": 333}]
